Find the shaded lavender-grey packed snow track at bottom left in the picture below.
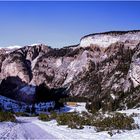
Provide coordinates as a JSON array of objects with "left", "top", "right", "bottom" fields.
[{"left": 0, "top": 117, "right": 55, "bottom": 139}]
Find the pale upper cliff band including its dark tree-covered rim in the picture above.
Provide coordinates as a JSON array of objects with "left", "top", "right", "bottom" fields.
[{"left": 80, "top": 30, "right": 140, "bottom": 48}]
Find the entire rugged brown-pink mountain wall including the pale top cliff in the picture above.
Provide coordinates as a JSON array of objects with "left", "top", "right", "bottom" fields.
[{"left": 0, "top": 31, "right": 140, "bottom": 106}]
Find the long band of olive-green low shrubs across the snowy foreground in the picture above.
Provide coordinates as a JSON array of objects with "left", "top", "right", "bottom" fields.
[{"left": 39, "top": 112, "right": 138, "bottom": 131}]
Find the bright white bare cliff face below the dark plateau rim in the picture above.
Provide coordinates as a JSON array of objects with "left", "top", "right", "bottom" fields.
[{"left": 80, "top": 32, "right": 140, "bottom": 48}]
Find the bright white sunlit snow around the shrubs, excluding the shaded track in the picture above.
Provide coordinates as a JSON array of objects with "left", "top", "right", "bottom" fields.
[{"left": 29, "top": 107, "right": 140, "bottom": 140}]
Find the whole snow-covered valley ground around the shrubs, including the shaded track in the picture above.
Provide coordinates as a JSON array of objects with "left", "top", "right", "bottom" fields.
[{"left": 0, "top": 103, "right": 140, "bottom": 140}]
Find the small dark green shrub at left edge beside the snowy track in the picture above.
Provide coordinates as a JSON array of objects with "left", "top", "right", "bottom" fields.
[{"left": 0, "top": 111, "right": 16, "bottom": 122}]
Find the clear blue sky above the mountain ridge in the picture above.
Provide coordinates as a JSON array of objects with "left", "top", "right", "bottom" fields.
[{"left": 0, "top": 1, "right": 140, "bottom": 47}]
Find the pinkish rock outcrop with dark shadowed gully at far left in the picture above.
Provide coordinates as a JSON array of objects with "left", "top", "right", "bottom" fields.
[{"left": 1, "top": 45, "right": 49, "bottom": 83}]
